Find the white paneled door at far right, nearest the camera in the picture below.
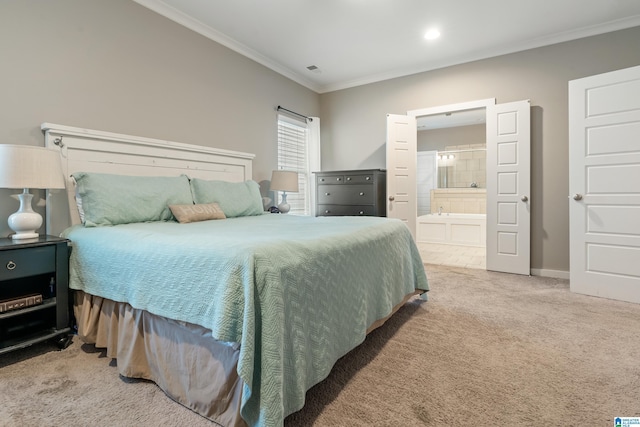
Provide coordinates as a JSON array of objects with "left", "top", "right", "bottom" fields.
[{"left": 569, "top": 67, "right": 640, "bottom": 303}]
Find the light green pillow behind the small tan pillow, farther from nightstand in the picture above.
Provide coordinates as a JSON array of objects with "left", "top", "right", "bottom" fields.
[{"left": 191, "top": 178, "right": 264, "bottom": 218}]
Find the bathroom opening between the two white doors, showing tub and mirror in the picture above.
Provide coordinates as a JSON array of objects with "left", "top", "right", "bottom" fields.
[{"left": 416, "top": 107, "right": 487, "bottom": 269}]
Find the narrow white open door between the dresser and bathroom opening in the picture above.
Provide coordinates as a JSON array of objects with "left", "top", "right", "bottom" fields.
[{"left": 387, "top": 114, "right": 418, "bottom": 239}]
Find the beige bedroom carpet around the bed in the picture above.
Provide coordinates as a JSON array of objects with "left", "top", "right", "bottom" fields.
[{"left": 0, "top": 265, "right": 640, "bottom": 427}]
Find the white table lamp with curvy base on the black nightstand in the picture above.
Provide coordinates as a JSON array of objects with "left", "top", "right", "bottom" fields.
[{"left": 0, "top": 144, "right": 64, "bottom": 240}]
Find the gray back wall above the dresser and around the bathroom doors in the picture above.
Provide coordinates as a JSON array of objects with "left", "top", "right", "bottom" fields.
[{"left": 320, "top": 27, "right": 640, "bottom": 271}]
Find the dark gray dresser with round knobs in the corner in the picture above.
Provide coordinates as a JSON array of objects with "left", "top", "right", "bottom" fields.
[{"left": 316, "top": 169, "right": 387, "bottom": 216}]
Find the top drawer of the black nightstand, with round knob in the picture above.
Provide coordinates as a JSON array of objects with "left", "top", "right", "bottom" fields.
[{"left": 0, "top": 245, "right": 56, "bottom": 280}]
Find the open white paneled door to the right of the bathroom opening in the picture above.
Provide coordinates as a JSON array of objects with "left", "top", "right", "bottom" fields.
[{"left": 487, "top": 100, "right": 531, "bottom": 275}]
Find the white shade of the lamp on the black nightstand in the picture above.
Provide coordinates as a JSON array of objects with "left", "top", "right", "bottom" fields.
[{"left": 0, "top": 144, "right": 64, "bottom": 189}]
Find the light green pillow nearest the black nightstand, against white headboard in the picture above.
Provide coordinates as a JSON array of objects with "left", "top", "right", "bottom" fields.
[{"left": 72, "top": 172, "right": 193, "bottom": 227}]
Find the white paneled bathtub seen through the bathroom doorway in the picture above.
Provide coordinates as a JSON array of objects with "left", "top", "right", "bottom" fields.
[{"left": 416, "top": 212, "right": 487, "bottom": 247}]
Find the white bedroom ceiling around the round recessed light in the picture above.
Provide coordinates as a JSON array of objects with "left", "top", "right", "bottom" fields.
[{"left": 134, "top": 0, "right": 640, "bottom": 93}]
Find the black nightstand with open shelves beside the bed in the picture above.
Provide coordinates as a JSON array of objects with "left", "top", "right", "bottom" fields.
[{"left": 0, "top": 236, "right": 71, "bottom": 354}]
